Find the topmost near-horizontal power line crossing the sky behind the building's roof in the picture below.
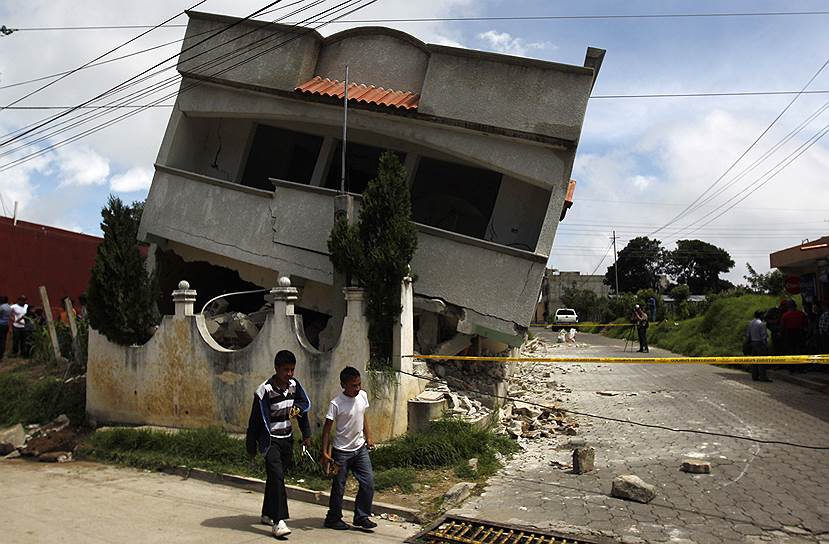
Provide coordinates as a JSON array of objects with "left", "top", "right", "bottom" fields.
[{"left": 9, "top": 10, "right": 829, "bottom": 32}]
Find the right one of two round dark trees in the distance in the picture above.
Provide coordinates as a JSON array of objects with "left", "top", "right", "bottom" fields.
[{"left": 666, "top": 240, "right": 734, "bottom": 293}]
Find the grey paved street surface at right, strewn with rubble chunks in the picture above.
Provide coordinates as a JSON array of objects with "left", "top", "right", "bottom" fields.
[{"left": 456, "top": 331, "right": 829, "bottom": 543}]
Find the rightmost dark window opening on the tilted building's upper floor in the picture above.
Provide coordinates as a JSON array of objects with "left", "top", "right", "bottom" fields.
[{"left": 412, "top": 157, "right": 501, "bottom": 239}]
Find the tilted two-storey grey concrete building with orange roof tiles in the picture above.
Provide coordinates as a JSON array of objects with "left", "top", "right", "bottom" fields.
[{"left": 140, "top": 12, "right": 604, "bottom": 353}]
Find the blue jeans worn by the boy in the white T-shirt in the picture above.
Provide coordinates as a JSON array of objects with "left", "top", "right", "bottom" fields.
[{"left": 325, "top": 445, "right": 374, "bottom": 523}]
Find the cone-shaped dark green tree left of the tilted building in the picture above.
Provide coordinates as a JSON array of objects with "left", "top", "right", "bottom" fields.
[{"left": 87, "top": 195, "right": 159, "bottom": 346}]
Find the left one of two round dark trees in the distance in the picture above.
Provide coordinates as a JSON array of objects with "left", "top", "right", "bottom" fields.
[{"left": 604, "top": 236, "right": 663, "bottom": 294}]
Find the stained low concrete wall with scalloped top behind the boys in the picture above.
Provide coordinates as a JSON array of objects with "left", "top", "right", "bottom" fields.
[{"left": 86, "top": 282, "right": 423, "bottom": 440}]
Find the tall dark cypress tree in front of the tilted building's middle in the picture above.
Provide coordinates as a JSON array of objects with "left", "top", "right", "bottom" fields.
[{"left": 328, "top": 152, "right": 417, "bottom": 368}]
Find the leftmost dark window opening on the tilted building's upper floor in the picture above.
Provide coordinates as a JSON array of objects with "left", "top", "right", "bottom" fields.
[{"left": 242, "top": 125, "right": 322, "bottom": 191}]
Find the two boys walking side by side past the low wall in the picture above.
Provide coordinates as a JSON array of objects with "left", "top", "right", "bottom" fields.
[{"left": 245, "top": 350, "right": 377, "bottom": 537}]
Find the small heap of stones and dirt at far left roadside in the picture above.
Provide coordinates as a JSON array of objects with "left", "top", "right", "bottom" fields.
[{"left": 0, "top": 414, "right": 78, "bottom": 463}]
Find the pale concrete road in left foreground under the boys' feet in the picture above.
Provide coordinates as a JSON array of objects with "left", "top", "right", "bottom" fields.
[{"left": 0, "top": 460, "right": 418, "bottom": 544}]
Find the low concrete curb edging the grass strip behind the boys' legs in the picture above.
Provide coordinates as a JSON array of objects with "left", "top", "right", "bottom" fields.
[{"left": 162, "top": 466, "right": 421, "bottom": 523}]
